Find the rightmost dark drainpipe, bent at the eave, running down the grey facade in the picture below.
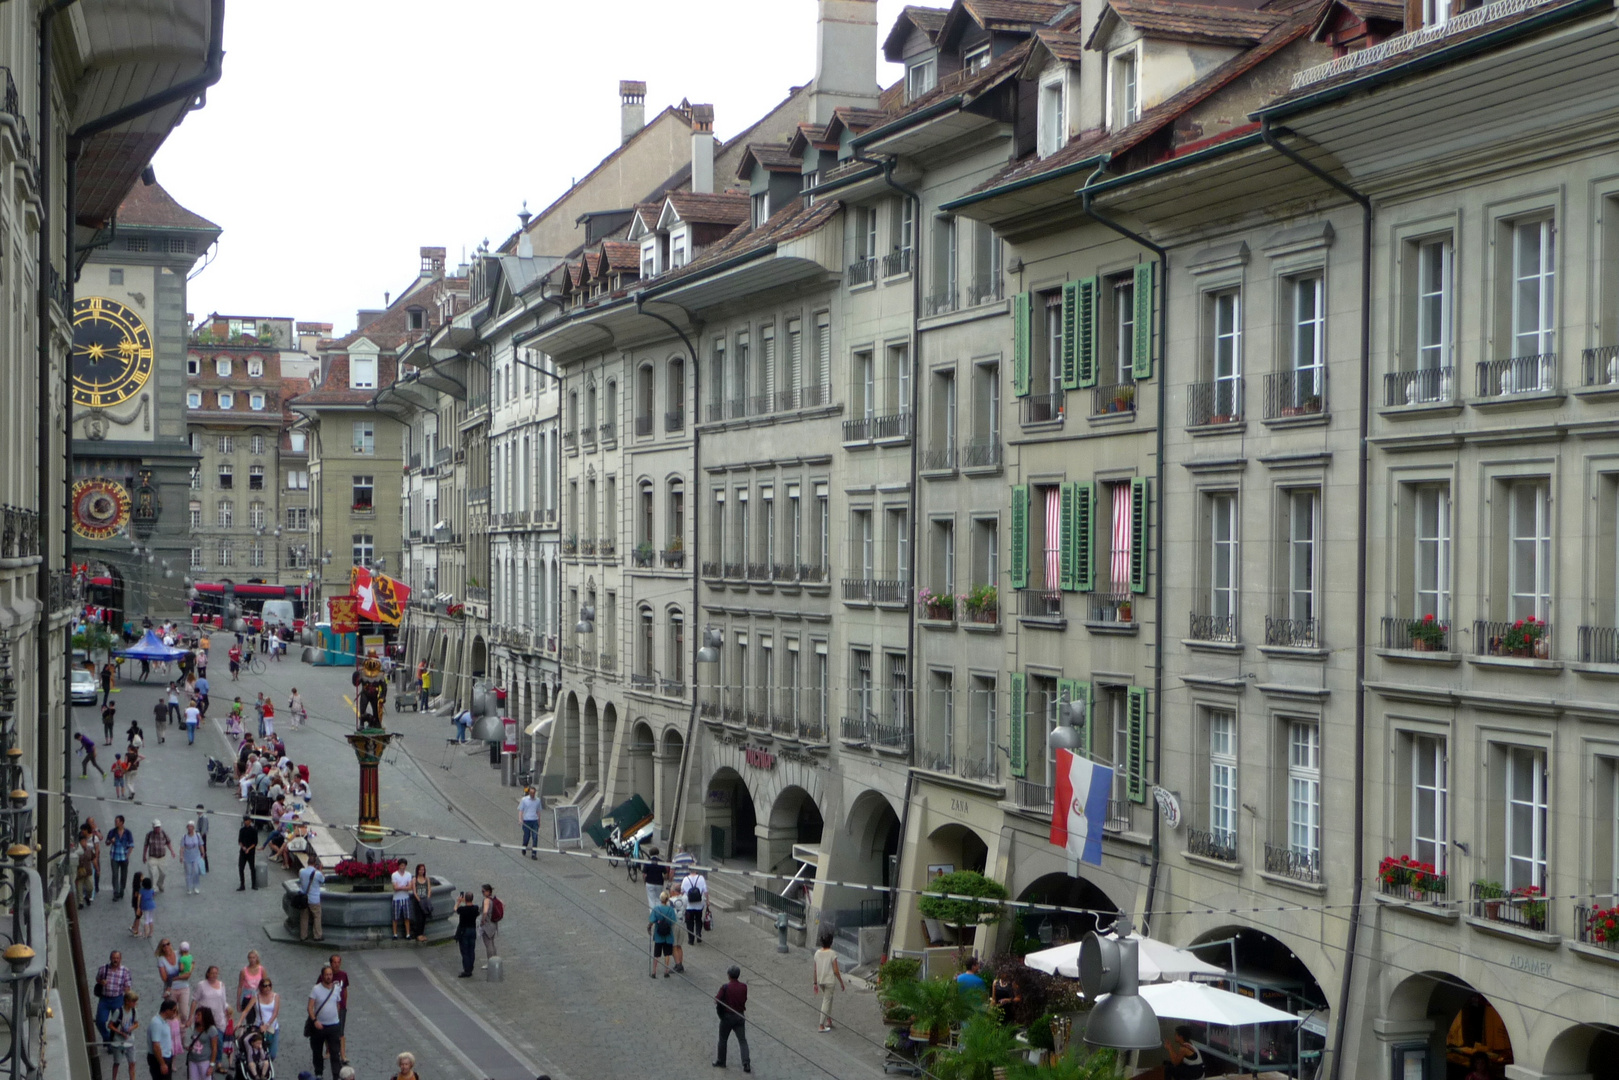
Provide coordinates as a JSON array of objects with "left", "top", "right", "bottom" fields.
[{"left": 1260, "top": 117, "right": 1371, "bottom": 1080}]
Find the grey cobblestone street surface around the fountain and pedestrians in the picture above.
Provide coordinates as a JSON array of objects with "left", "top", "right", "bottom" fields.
[{"left": 74, "top": 647, "right": 882, "bottom": 1080}]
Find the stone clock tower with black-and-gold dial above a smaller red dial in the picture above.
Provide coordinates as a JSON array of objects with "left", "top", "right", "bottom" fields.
[{"left": 68, "top": 183, "right": 220, "bottom": 623}]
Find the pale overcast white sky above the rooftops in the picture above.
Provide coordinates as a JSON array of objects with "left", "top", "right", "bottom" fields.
[{"left": 154, "top": 0, "right": 919, "bottom": 335}]
